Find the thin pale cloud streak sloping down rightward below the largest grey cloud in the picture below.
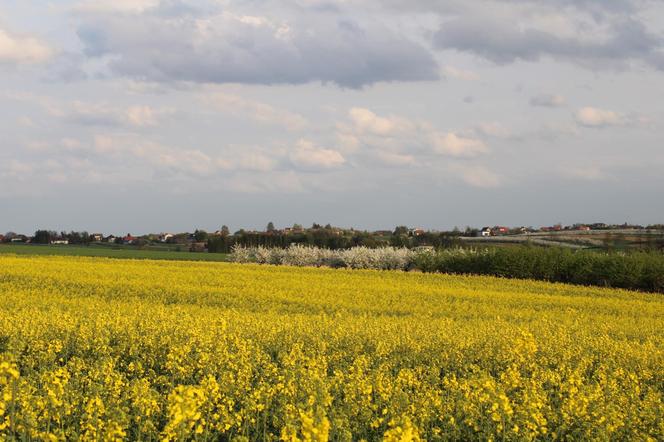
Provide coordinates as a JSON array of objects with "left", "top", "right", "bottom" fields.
[{"left": 205, "top": 93, "right": 307, "bottom": 131}]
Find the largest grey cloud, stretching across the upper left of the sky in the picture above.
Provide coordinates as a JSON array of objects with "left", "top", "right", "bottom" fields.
[{"left": 78, "top": 1, "right": 440, "bottom": 88}]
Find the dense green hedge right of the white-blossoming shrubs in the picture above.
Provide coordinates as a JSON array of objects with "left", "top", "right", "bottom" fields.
[{"left": 413, "top": 247, "right": 664, "bottom": 293}]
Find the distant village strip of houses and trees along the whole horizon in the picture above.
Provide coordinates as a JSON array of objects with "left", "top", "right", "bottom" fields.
[{"left": 0, "top": 223, "right": 664, "bottom": 251}]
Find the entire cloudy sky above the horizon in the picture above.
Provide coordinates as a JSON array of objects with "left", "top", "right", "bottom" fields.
[{"left": 0, "top": 0, "right": 664, "bottom": 234}]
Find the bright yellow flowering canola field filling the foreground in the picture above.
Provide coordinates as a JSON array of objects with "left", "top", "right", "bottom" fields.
[{"left": 0, "top": 255, "right": 664, "bottom": 441}]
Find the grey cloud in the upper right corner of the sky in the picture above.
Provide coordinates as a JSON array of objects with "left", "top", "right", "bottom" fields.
[{"left": 433, "top": 0, "right": 664, "bottom": 69}]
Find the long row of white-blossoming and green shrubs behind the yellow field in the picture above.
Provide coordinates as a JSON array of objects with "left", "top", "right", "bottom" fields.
[{"left": 231, "top": 245, "right": 664, "bottom": 292}]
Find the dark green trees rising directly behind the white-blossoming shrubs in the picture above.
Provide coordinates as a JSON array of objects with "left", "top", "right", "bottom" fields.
[{"left": 207, "top": 227, "right": 462, "bottom": 253}]
